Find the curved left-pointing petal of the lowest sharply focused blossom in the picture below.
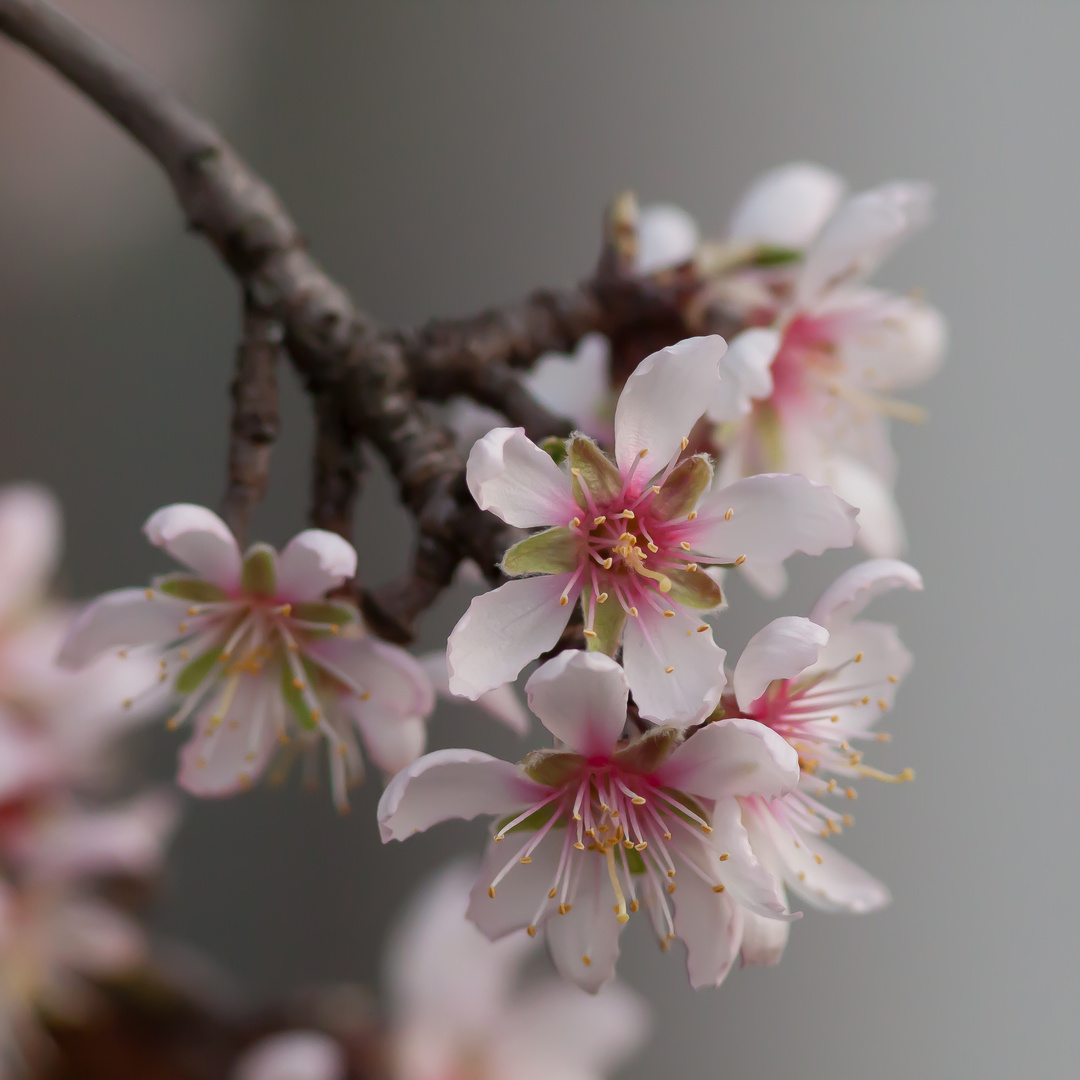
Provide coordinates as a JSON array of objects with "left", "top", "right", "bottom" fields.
[{"left": 378, "top": 750, "right": 550, "bottom": 843}]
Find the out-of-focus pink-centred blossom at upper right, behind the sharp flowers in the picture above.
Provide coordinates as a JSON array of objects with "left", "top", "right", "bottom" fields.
[{"left": 708, "top": 183, "right": 945, "bottom": 593}]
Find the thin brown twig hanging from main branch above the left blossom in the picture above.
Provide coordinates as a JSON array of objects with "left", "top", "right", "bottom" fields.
[{"left": 221, "top": 307, "right": 282, "bottom": 544}]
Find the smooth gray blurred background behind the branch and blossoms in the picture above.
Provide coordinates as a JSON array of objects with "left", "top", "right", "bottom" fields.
[{"left": 0, "top": 0, "right": 1080, "bottom": 1080}]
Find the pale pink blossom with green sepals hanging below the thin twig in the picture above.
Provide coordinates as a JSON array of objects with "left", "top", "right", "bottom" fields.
[{"left": 60, "top": 503, "right": 434, "bottom": 809}]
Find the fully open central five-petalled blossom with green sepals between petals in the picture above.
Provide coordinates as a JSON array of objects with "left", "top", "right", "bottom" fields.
[{"left": 447, "top": 337, "right": 856, "bottom": 724}]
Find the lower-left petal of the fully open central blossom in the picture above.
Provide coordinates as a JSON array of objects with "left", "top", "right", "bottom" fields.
[{"left": 446, "top": 573, "right": 581, "bottom": 701}]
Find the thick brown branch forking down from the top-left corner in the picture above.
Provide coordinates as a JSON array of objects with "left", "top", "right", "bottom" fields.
[{"left": 0, "top": 0, "right": 747, "bottom": 640}]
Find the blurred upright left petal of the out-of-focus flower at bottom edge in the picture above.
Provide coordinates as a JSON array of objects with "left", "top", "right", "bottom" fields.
[{"left": 387, "top": 859, "right": 534, "bottom": 1037}]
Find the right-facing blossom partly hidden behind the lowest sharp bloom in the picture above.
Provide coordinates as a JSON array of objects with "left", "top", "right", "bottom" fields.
[{"left": 725, "top": 559, "right": 922, "bottom": 963}]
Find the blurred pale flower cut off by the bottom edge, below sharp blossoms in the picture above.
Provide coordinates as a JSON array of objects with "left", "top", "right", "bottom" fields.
[{"left": 387, "top": 864, "right": 649, "bottom": 1080}]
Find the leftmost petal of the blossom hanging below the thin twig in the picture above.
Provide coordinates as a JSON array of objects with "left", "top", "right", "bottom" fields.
[{"left": 57, "top": 589, "right": 188, "bottom": 667}]
